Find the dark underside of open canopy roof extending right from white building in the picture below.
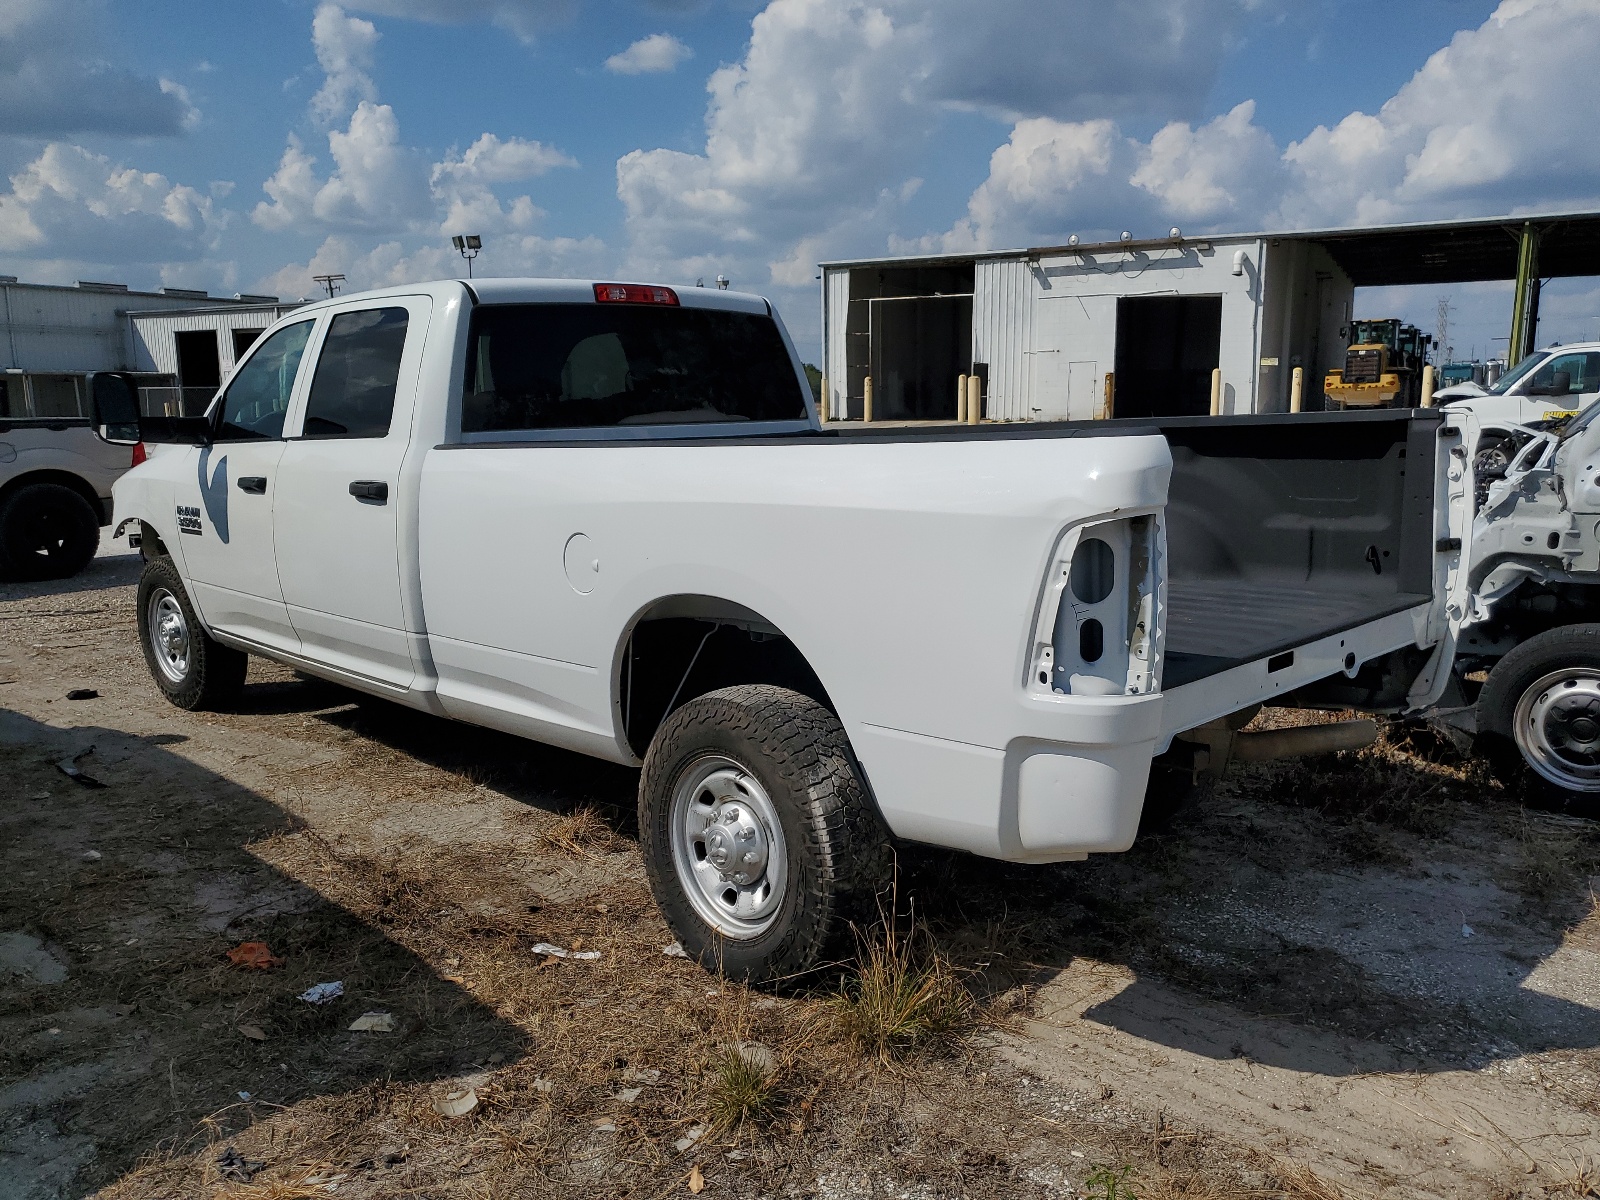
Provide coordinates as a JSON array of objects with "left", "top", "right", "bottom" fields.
[{"left": 1277, "top": 213, "right": 1600, "bottom": 288}]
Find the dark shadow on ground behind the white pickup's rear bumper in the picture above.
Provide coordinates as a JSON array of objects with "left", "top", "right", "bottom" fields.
[{"left": 902, "top": 755, "right": 1600, "bottom": 1075}]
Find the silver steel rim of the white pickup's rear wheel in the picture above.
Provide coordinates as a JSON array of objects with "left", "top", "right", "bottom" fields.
[{"left": 667, "top": 754, "right": 789, "bottom": 941}]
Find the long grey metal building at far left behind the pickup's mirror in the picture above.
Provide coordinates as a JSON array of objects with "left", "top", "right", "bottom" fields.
[{"left": 0, "top": 275, "right": 288, "bottom": 418}]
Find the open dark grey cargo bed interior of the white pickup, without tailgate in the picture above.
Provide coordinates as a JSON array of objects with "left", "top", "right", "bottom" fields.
[{"left": 1152, "top": 410, "right": 1438, "bottom": 688}]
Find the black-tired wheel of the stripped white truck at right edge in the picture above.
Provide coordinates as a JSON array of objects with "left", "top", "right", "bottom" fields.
[{"left": 1477, "top": 622, "right": 1600, "bottom": 816}]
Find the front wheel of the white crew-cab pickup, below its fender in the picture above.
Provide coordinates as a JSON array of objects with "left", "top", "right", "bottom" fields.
[{"left": 138, "top": 555, "right": 250, "bottom": 710}]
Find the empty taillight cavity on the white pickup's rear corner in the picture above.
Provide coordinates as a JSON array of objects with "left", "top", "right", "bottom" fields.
[{"left": 1029, "top": 515, "right": 1163, "bottom": 696}]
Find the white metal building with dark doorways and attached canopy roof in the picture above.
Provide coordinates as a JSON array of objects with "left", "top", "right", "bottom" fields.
[{"left": 822, "top": 213, "right": 1600, "bottom": 421}]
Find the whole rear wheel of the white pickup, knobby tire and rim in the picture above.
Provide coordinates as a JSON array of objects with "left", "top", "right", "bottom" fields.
[{"left": 638, "top": 683, "right": 893, "bottom": 982}]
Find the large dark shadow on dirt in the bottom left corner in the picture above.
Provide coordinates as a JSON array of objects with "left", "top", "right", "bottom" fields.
[{"left": 0, "top": 709, "right": 525, "bottom": 1200}]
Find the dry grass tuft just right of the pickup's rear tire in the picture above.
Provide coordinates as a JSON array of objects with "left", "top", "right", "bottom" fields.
[{"left": 834, "top": 922, "right": 978, "bottom": 1062}]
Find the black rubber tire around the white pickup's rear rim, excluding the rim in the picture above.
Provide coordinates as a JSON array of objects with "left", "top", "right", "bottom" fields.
[{"left": 638, "top": 683, "right": 894, "bottom": 982}]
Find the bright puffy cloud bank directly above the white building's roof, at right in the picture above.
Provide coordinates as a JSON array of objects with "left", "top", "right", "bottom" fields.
[{"left": 915, "top": 0, "right": 1600, "bottom": 251}]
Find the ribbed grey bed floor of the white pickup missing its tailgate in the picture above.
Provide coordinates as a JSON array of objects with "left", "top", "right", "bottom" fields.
[{"left": 1162, "top": 579, "right": 1429, "bottom": 688}]
